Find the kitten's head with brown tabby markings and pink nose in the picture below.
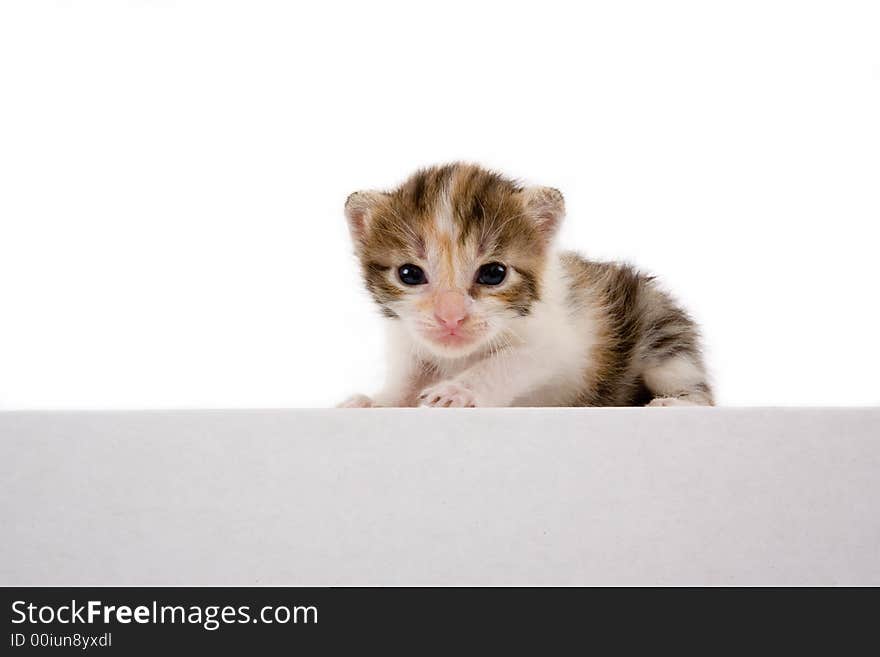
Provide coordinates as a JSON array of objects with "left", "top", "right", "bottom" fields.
[{"left": 345, "top": 164, "right": 564, "bottom": 357}]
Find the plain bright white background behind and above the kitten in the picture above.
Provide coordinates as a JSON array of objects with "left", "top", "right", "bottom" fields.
[{"left": 0, "top": 0, "right": 880, "bottom": 409}]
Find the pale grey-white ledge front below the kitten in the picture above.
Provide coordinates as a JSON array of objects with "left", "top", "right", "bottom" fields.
[{"left": 0, "top": 409, "right": 880, "bottom": 585}]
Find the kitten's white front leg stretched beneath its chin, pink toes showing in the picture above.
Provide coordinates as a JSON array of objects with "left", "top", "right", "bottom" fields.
[{"left": 419, "top": 347, "right": 556, "bottom": 408}]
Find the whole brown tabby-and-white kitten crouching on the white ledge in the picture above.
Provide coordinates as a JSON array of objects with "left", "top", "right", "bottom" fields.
[{"left": 341, "top": 164, "right": 713, "bottom": 407}]
